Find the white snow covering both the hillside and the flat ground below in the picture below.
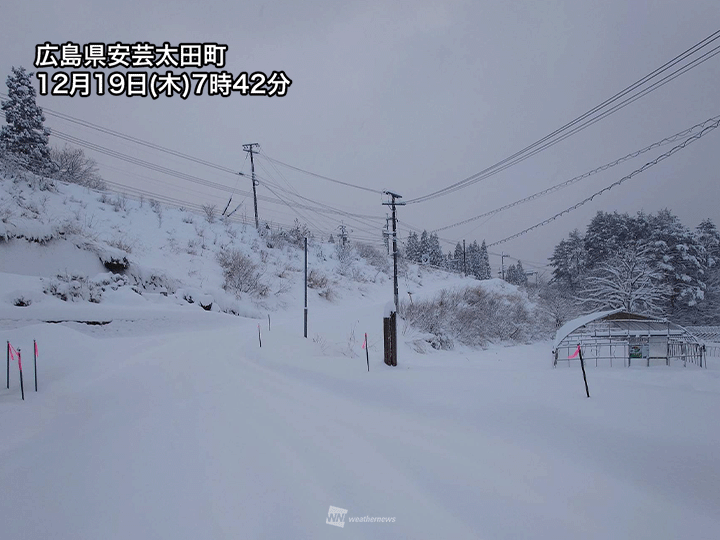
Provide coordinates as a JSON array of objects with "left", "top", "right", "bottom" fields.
[{"left": 0, "top": 175, "right": 720, "bottom": 540}]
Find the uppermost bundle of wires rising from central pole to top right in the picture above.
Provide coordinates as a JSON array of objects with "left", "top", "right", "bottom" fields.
[{"left": 406, "top": 30, "right": 720, "bottom": 204}]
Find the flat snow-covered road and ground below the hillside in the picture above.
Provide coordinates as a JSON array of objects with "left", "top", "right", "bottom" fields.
[{"left": 0, "top": 303, "right": 720, "bottom": 540}]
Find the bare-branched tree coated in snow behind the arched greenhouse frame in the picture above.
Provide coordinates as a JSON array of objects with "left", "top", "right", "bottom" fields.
[{"left": 577, "top": 243, "right": 669, "bottom": 314}]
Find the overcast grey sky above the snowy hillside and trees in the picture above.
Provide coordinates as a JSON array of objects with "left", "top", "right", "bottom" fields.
[{"left": 0, "top": 0, "right": 720, "bottom": 274}]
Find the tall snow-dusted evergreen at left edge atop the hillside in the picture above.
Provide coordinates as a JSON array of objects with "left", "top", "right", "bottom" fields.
[{"left": 0, "top": 67, "right": 52, "bottom": 174}]
